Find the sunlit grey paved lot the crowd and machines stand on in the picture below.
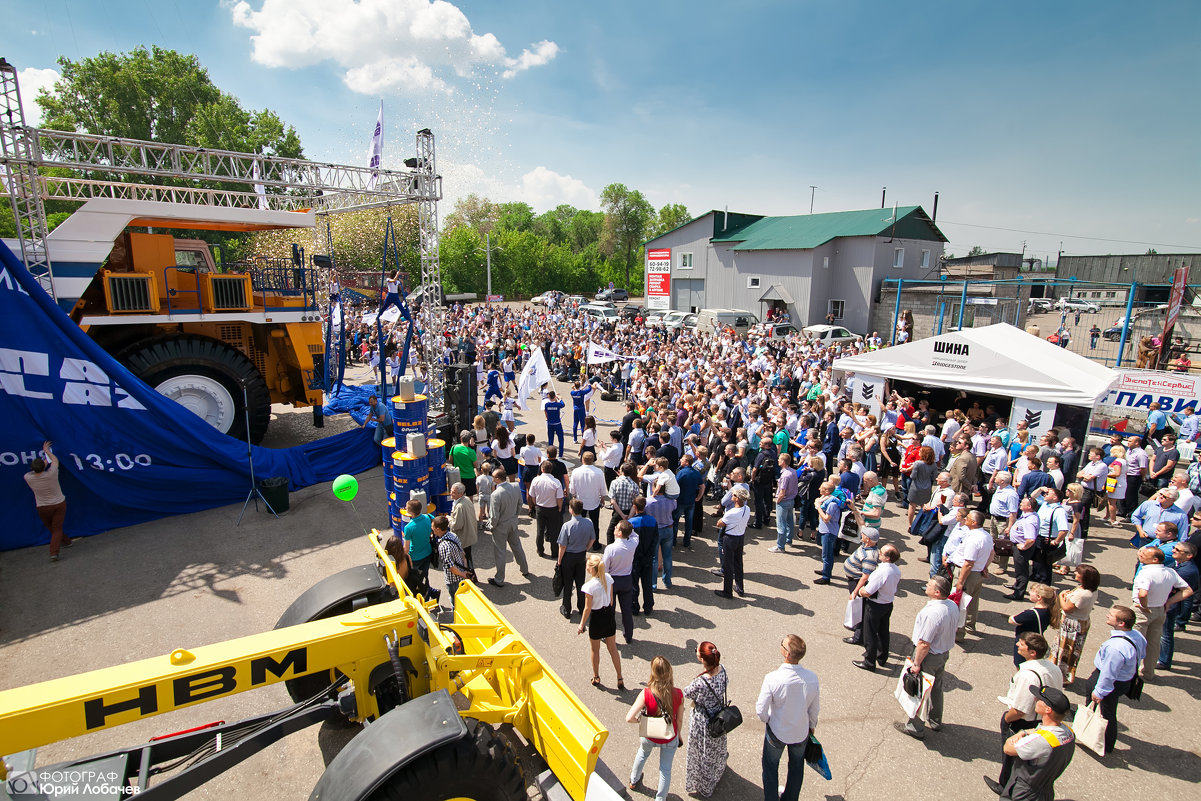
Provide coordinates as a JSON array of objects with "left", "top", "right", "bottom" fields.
[{"left": 0, "top": 372, "right": 1201, "bottom": 801}]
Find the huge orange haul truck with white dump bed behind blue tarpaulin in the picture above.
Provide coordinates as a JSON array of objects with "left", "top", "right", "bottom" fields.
[{"left": 31, "top": 198, "right": 325, "bottom": 442}]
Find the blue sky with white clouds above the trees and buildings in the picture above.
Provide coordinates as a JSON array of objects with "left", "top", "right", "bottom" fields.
[{"left": 0, "top": 0, "right": 1201, "bottom": 258}]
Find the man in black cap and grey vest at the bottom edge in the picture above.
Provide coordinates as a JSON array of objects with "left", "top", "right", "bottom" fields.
[{"left": 988, "top": 687, "right": 1076, "bottom": 801}]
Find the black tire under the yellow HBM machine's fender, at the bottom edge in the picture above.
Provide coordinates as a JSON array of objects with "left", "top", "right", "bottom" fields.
[{"left": 370, "top": 718, "right": 527, "bottom": 801}]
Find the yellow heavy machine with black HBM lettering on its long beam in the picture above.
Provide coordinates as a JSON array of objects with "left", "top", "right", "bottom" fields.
[{"left": 0, "top": 536, "right": 617, "bottom": 801}]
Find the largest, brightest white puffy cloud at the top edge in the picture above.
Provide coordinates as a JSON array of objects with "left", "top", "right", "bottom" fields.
[{"left": 229, "top": 0, "right": 558, "bottom": 94}]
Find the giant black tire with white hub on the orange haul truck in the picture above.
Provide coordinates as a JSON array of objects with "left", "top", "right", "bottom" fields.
[{"left": 119, "top": 336, "right": 271, "bottom": 443}]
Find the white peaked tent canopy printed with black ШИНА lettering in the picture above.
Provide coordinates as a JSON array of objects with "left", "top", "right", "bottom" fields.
[{"left": 832, "top": 323, "right": 1118, "bottom": 407}]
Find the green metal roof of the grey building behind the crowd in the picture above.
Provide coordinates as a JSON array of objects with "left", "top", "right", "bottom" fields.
[{"left": 712, "top": 205, "right": 949, "bottom": 250}]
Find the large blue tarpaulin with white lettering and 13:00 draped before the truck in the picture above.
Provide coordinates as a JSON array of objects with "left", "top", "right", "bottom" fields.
[{"left": 0, "top": 244, "right": 380, "bottom": 550}]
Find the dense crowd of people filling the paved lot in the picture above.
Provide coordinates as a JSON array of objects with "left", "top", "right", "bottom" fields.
[{"left": 365, "top": 296, "right": 1201, "bottom": 800}]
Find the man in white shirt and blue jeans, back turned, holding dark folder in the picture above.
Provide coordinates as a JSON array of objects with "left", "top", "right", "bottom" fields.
[{"left": 754, "top": 634, "right": 821, "bottom": 801}]
